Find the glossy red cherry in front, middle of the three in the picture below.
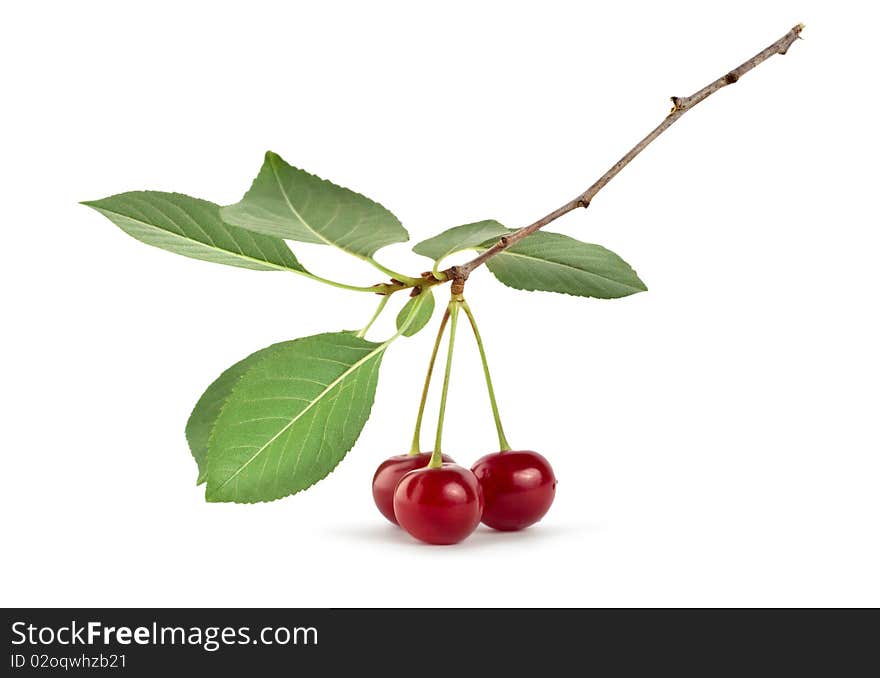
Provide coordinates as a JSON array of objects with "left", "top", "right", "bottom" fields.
[{"left": 394, "top": 464, "right": 483, "bottom": 544}]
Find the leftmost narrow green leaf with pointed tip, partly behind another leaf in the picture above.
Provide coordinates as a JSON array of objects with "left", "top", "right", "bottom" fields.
[{"left": 82, "top": 191, "right": 305, "bottom": 272}]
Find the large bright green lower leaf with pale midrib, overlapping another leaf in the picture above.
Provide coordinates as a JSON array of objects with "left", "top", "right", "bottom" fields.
[{"left": 205, "top": 332, "right": 388, "bottom": 503}]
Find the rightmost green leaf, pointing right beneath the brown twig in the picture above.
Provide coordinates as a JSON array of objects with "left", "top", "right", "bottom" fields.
[{"left": 481, "top": 231, "right": 647, "bottom": 299}]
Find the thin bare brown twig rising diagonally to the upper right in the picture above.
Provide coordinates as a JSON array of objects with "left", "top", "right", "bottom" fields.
[{"left": 423, "top": 24, "right": 804, "bottom": 293}]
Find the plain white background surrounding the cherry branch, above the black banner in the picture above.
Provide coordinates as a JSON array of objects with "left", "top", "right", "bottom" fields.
[{"left": 0, "top": 0, "right": 880, "bottom": 606}]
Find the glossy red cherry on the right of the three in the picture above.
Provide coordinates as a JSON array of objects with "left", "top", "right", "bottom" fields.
[{"left": 471, "top": 450, "right": 556, "bottom": 531}]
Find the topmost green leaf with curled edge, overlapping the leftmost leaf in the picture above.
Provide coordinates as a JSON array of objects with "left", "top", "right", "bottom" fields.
[{"left": 221, "top": 151, "right": 409, "bottom": 259}]
